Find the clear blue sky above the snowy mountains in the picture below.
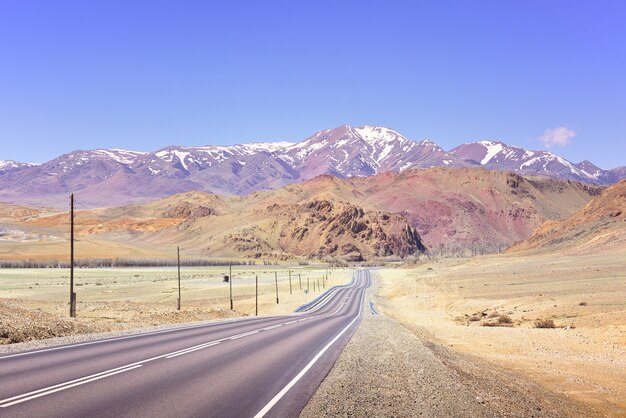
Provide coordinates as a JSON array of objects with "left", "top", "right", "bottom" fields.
[{"left": 0, "top": 0, "right": 626, "bottom": 168}]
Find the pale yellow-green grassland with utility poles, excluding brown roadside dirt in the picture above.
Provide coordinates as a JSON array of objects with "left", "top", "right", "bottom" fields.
[{"left": 0, "top": 265, "right": 353, "bottom": 328}]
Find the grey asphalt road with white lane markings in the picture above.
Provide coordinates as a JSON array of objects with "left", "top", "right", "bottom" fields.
[{"left": 0, "top": 270, "right": 371, "bottom": 418}]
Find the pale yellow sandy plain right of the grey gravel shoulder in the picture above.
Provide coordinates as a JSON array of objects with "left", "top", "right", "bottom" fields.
[{"left": 375, "top": 253, "right": 626, "bottom": 416}]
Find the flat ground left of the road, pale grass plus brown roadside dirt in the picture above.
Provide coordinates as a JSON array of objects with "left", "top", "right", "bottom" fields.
[{"left": 0, "top": 265, "right": 352, "bottom": 344}]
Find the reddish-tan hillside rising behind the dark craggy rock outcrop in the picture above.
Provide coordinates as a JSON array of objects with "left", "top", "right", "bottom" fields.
[{"left": 251, "top": 168, "right": 602, "bottom": 255}]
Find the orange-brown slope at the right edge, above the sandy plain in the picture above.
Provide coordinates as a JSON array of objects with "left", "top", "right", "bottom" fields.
[{"left": 509, "top": 180, "right": 626, "bottom": 254}]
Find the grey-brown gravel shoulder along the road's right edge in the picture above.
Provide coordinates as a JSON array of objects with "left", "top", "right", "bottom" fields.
[{"left": 301, "top": 280, "right": 600, "bottom": 418}]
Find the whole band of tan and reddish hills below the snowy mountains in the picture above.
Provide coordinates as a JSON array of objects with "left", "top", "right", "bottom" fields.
[{"left": 0, "top": 168, "right": 602, "bottom": 260}]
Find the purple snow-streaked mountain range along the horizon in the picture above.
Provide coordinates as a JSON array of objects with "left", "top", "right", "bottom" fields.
[{"left": 0, "top": 125, "right": 626, "bottom": 208}]
